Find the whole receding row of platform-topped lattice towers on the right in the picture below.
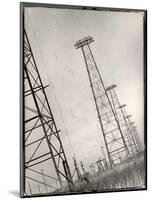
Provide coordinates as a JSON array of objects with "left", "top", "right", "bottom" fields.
[{"left": 75, "top": 36, "right": 143, "bottom": 167}]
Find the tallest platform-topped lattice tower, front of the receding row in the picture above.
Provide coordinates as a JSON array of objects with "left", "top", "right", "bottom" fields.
[{"left": 74, "top": 36, "right": 130, "bottom": 167}]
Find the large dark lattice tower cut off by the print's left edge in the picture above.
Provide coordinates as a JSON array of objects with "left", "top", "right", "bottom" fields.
[{"left": 24, "top": 31, "right": 73, "bottom": 194}]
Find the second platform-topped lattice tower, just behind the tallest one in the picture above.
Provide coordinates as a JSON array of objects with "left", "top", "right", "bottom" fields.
[{"left": 106, "top": 85, "right": 137, "bottom": 156}]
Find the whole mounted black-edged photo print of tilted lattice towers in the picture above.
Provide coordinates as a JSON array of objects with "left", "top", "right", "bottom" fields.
[{"left": 20, "top": 3, "right": 147, "bottom": 197}]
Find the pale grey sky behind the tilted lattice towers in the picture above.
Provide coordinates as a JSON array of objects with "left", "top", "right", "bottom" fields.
[{"left": 25, "top": 8, "right": 144, "bottom": 174}]
